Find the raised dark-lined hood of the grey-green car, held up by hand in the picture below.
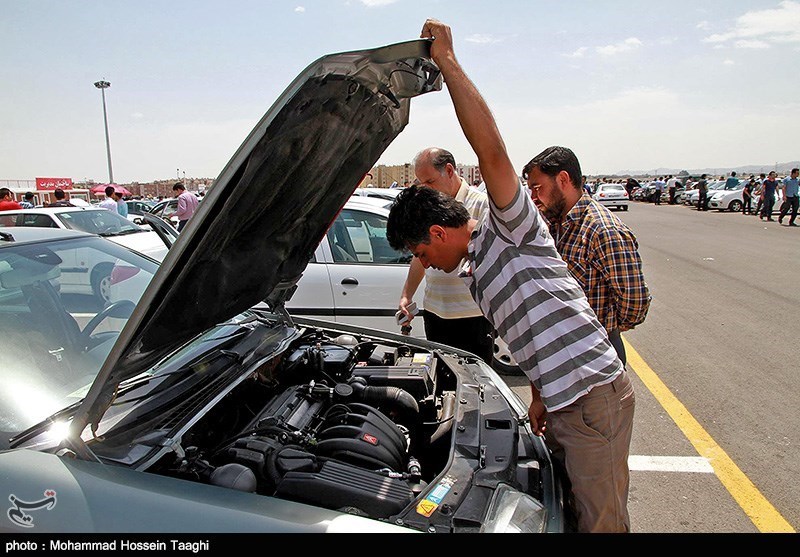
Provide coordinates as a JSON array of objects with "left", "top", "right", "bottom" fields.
[{"left": 71, "top": 39, "right": 441, "bottom": 437}]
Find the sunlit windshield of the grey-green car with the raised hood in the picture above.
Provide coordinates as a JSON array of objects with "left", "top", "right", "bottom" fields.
[{"left": 0, "top": 235, "right": 157, "bottom": 438}]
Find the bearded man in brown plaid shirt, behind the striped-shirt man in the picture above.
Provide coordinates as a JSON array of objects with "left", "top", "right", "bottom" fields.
[{"left": 522, "top": 146, "right": 650, "bottom": 364}]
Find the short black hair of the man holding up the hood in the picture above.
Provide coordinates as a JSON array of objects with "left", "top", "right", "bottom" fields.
[{"left": 386, "top": 186, "right": 470, "bottom": 251}]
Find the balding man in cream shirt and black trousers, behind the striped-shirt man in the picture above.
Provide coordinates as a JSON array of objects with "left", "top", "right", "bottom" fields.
[{"left": 398, "top": 147, "right": 494, "bottom": 364}]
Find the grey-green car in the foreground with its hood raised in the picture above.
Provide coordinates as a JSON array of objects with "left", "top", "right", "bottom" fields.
[{"left": 0, "top": 40, "right": 564, "bottom": 534}]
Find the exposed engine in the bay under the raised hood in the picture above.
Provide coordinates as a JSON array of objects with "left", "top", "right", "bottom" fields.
[{"left": 151, "top": 330, "right": 456, "bottom": 518}]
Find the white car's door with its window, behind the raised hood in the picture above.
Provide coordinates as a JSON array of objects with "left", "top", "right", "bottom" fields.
[{"left": 287, "top": 204, "right": 425, "bottom": 337}]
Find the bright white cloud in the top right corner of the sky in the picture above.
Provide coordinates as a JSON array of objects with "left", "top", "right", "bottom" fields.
[{"left": 703, "top": 0, "right": 800, "bottom": 48}]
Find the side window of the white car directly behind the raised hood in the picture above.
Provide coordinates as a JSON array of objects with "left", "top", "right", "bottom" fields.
[{"left": 328, "top": 209, "right": 411, "bottom": 265}]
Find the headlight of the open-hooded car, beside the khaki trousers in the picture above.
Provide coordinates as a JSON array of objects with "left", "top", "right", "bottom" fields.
[{"left": 481, "top": 484, "right": 547, "bottom": 534}]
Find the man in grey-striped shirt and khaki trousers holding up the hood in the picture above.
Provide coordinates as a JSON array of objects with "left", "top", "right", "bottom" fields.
[{"left": 387, "top": 19, "right": 635, "bottom": 532}]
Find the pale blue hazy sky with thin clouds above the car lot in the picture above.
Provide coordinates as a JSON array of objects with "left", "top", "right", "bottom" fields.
[{"left": 0, "top": 0, "right": 800, "bottom": 183}]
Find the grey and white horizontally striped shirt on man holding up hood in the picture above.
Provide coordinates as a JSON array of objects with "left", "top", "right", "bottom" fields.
[{"left": 461, "top": 186, "right": 622, "bottom": 412}]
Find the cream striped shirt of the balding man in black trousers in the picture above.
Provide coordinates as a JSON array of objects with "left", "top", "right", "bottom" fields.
[{"left": 422, "top": 178, "right": 489, "bottom": 319}]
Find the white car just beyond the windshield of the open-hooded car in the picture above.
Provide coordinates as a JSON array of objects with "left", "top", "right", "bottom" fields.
[{"left": 0, "top": 207, "right": 174, "bottom": 303}]
